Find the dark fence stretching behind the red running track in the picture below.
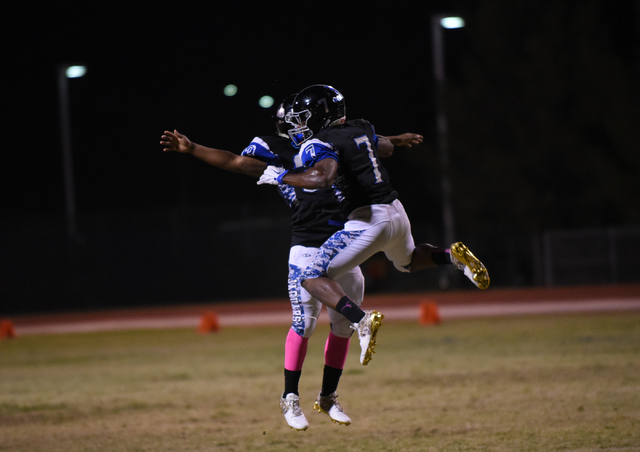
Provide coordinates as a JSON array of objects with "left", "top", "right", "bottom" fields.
[{"left": 0, "top": 205, "right": 640, "bottom": 314}]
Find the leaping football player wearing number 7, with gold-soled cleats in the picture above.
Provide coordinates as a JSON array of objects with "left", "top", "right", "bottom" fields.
[{"left": 258, "top": 85, "right": 490, "bottom": 374}]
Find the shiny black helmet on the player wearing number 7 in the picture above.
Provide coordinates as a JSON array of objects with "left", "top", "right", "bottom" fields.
[{"left": 285, "top": 85, "right": 346, "bottom": 146}]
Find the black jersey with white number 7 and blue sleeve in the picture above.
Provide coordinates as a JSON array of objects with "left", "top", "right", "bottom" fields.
[{"left": 300, "top": 119, "right": 398, "bottom": 215}]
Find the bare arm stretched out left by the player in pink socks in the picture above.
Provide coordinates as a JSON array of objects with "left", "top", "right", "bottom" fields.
[{"left": 160, "top": 130, "right": 267, "bottom": 177}]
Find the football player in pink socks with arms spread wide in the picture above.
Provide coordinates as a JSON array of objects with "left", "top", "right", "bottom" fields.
[{"left": 160, "top": 95, "right": 422, "bottom": 430}]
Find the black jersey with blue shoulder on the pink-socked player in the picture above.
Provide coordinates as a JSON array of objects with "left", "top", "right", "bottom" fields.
[{"left": 242, "top": 136, "right": 346, "bottom": 248}]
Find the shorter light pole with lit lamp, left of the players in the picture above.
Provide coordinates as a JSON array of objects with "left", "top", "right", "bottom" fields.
[{"left": 58, "top": 64, "right": 87, "bottom": 238}]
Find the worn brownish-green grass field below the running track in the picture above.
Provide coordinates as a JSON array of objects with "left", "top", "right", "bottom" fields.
[{"left": 0, "top": 314, "right": 640, "bottom": 452}]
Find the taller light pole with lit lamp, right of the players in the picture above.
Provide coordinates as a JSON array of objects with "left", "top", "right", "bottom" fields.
[{"left": 431, "top": 14, "right": 464, "bottom": 246}]
